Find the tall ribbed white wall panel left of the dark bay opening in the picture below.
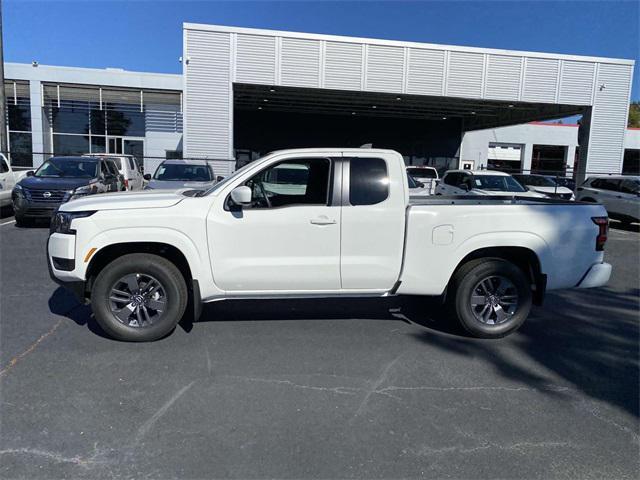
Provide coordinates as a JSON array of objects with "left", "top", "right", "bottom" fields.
[{"left": 185, "top": 31, "right": 232, "bottom": 158}]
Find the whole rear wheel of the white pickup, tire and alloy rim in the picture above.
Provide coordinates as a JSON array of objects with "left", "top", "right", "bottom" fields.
[{"left": 450, "top": 258, "right": 532, "bottom": 338}]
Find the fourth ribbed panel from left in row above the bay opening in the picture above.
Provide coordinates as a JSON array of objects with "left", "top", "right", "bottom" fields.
[{"left": 365, "top": 45, "right": 404, "bottom": 93}]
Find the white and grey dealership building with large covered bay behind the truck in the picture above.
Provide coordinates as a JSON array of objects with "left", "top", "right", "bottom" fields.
[{"left": 5, "top": 23, "right": 638, "bottom": 177}]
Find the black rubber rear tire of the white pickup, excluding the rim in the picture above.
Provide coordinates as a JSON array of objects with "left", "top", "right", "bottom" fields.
[{"left": 449, "top": 258, "right": 532, "bottom": 338}]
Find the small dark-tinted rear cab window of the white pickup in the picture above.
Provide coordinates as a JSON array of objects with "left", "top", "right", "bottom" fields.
[{"left": 349, "top": 158, "right": 389, "bottom": 205}]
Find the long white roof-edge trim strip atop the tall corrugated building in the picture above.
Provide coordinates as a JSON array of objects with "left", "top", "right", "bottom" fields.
[{"left": 182, "top": 22, "right": 635, "bottom": 65}]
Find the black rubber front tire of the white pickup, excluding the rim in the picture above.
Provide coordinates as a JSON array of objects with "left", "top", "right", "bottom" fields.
[{"left": 91, "top": 253, "right": 188, "bottom": 342}]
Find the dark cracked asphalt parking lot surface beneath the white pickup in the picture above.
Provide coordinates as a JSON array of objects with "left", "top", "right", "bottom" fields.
[{"left": 0, "top": 218, "right": 640, "bottom": 479}]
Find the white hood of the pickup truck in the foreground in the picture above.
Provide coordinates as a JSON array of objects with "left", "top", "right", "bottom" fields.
[{"left": 60, "top": 190, "right": 185, "bottom": 212}]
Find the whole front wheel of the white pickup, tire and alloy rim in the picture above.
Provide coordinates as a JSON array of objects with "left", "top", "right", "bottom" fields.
[{"left": 91, "top": 253, "right": 188, "bottom": 342}]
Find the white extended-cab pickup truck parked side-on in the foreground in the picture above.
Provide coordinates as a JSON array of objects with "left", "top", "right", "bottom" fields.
[{"left": 47, "top": 149, "right": 611, "bottom": 341}]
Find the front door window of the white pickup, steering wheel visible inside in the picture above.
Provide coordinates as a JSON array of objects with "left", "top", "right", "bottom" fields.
[{"left": 245, "top": 158, "right": 331, "bottom": 208}]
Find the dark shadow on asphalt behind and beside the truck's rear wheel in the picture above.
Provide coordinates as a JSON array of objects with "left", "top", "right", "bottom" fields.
[{"left": 415, "top": 288, "right": 640, "bottom": 417}]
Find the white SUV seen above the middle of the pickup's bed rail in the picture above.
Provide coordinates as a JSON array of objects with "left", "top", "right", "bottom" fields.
[{"left": 436, "top": 170, "right": 546, "bottom": 198}]
